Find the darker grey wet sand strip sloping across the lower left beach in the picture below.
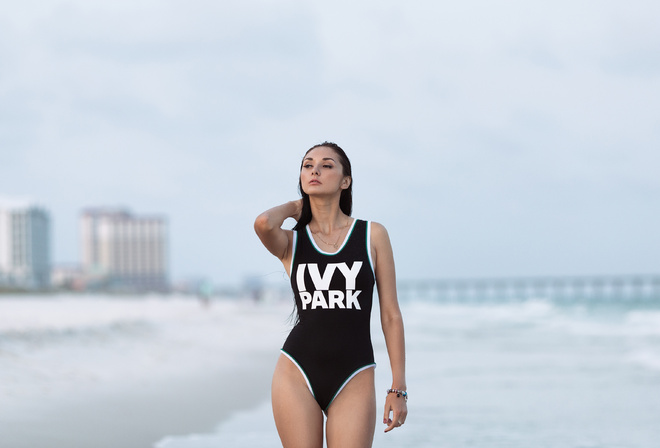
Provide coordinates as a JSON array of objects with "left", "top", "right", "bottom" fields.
[{"left": 0, "top": 353, "right": 277, "bottom": 448}]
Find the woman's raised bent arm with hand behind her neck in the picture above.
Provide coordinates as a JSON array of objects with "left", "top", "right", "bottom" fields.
[{"left": 254, "top": 199, "right": 302, "bottom": 269}]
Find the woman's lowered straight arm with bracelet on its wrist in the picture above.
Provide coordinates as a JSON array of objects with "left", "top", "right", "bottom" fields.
[{"left": 371, "top": 222, "right": 408, "bottom": 432}]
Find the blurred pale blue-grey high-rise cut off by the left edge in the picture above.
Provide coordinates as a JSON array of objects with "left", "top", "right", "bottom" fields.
[{"left": 0, "top": 203, "right": 51, "bottom": 289}]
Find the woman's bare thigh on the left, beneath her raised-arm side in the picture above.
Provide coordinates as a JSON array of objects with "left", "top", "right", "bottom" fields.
[{"left": 271, "top": 355, "right": 323, "bottom": 448}]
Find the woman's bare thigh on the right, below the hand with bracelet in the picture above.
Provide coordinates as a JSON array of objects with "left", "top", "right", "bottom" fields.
[{"left": 326, "top": 368, "right": 376, "bottom": 448}]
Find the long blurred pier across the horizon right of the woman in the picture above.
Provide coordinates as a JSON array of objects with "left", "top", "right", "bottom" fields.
[{"left": 397, "top": 274, "right": 660, "bottom": 302}]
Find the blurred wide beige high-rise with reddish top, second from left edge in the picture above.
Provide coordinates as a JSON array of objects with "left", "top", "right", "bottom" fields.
[{"left": 80, "top": 208, "right": 168, "bottom": 292}]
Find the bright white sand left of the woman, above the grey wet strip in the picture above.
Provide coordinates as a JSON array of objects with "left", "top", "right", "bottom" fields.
[{"left": 0, "top": 295, "right": 288, "bottom": 430}]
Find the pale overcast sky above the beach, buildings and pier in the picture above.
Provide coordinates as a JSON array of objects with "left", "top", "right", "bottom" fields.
[{"left": 0, "top": 0, "right": 660, "bottom": 284}]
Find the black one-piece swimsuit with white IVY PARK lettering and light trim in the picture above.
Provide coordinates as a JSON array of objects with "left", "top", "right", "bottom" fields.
[{"left": 282, "top": 219, "right": 376, "bottom": 413}]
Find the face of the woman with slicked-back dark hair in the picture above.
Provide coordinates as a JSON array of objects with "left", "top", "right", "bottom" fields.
[{"left": 300, "top": 146, "right": 351, "bottom": 196}]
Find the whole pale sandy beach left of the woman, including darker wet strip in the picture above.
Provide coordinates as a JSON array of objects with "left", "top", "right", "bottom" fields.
[{"left": 0, "top": 299, "right": 287, "bottom": 448}]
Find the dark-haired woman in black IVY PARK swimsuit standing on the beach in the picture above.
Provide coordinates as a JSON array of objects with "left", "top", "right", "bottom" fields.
[{"left": 254, "top": 142, "right": 408, "bottom": 448}]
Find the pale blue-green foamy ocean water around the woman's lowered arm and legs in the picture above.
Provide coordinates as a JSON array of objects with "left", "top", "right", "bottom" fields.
[{"left": 156, "top": 300, "right": 660, "bottom": 448}]
